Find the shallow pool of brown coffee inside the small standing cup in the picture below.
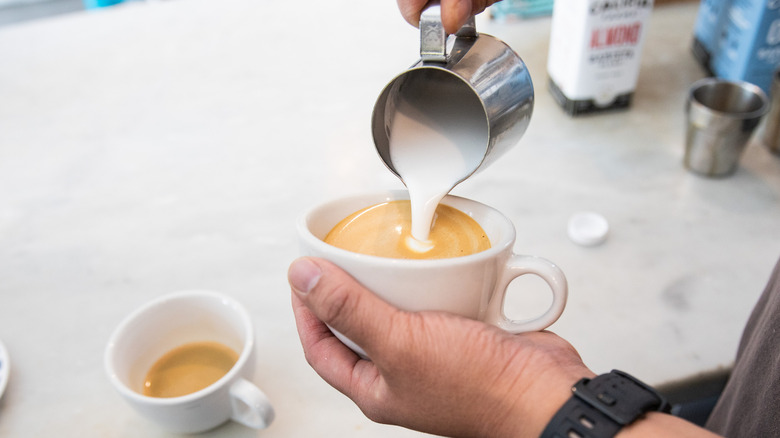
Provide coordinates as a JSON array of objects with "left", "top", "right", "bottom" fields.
[{"left": 143, "top": 341, "right": 239, "bottom": 397}]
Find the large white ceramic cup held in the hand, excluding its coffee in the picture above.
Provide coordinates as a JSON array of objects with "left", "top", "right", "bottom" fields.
[{"left": 298, "top": 191, "right": 568, "bottom": 357}]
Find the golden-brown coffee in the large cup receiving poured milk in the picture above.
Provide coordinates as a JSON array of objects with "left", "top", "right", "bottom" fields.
[{"left": 324, "top": 200, "right": 490, "bottom": 259}]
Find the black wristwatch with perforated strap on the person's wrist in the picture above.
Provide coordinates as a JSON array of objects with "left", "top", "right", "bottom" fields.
[{"left": 541, "top": 370, "right": 669, "bottom": 438}]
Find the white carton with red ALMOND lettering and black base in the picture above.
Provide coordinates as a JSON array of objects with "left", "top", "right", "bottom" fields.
[{"left": 547, "top": 0, "right": 653, "bottom": 115}]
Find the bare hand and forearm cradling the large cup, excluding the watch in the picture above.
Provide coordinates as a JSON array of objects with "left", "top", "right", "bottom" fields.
[{"left": 288, "top": 258, "right": 724, "bottom": 438}]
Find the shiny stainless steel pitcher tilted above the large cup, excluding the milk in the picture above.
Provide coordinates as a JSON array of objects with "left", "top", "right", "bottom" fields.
[{"left": 372, "top": 4, "right": 534, "bottom": 183}]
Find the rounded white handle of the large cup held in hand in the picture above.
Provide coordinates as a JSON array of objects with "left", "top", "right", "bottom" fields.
[{"left": 486, "top": 254, "right": 568, "bottom": 333}]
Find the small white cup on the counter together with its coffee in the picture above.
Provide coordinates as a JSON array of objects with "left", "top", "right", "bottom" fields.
[{"left": 105, "top": 291, "right": 274, "bottom": 433}]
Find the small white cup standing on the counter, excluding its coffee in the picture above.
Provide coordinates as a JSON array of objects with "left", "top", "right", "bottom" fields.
[{"left": 105, "top": 291, "right": 274, "bottom": 433}]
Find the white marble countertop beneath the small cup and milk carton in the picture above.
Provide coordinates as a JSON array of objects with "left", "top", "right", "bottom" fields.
[{"left": 0, "top": 0, "right": 780, "bottom": 437}]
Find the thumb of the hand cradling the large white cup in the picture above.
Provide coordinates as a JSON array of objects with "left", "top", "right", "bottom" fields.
[{"left": 287, "top": 257, "right": 398, "bottom": 355}]
